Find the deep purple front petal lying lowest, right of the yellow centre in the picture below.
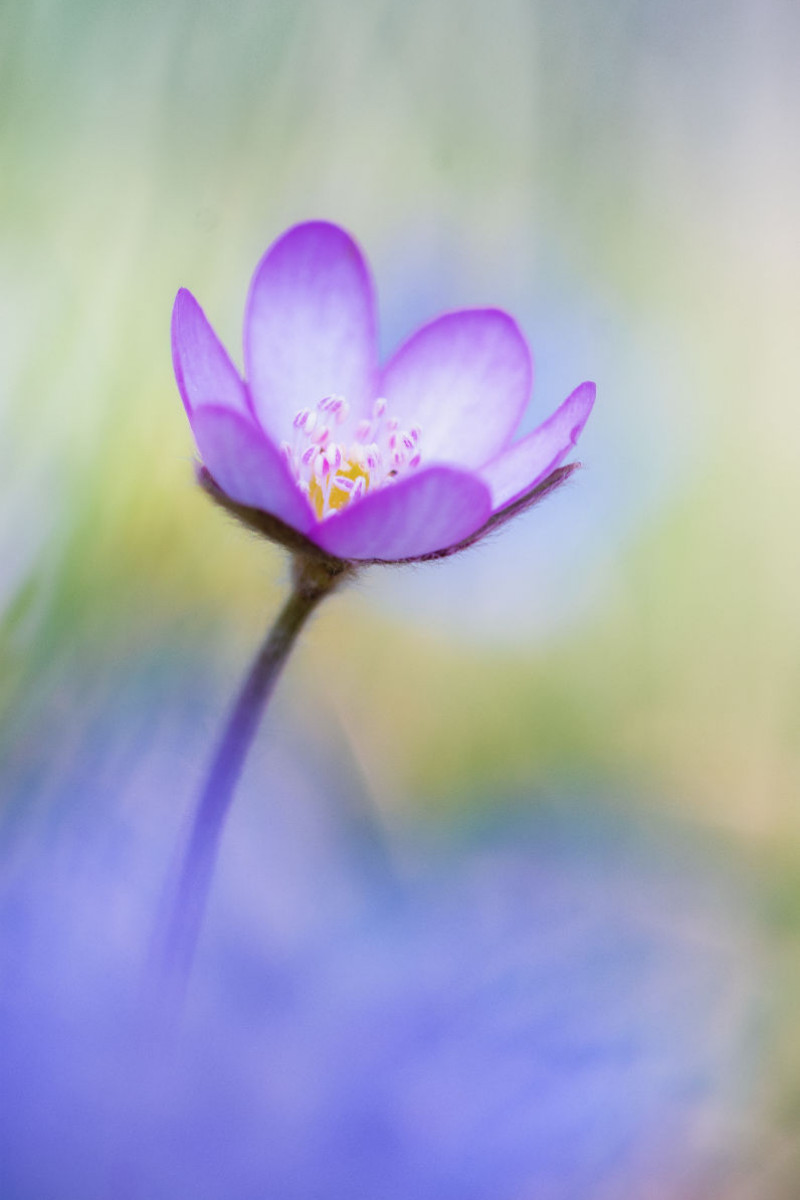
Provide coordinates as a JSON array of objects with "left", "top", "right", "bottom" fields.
[{"left": 309, "top": 467, "right": 492, "bottom": 560}]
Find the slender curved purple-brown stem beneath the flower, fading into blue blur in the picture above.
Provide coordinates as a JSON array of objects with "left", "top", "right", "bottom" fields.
[{"left": 157, "top": 556, "right": 353, "bottom": 1008}]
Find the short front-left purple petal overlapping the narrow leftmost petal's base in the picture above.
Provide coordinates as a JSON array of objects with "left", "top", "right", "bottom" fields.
[{"left": 191, "top": 404, "right": 314, "bottom": 533}]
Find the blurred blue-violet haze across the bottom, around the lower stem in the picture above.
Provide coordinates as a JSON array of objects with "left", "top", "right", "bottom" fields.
[{"left": 0, "top": 685, "right": 762, "bottom": 1200}]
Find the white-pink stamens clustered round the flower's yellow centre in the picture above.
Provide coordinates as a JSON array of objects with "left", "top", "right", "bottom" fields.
[{"left": 281, "top": 396, "right": 421, "bottom": 521}]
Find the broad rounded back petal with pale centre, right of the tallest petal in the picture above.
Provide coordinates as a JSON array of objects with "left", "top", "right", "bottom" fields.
[{"left": 380, "top": 308, "right": 533, "bottom": 467}]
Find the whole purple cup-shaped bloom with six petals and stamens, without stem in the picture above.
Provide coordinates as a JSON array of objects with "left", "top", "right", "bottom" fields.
[{"left": 173, "top": 221, "right": 595, "bottom": 562}]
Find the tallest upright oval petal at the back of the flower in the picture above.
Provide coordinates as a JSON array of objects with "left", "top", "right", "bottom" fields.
[{"left": 245, "top": 221, "right": 378, "bottom": 442}]
